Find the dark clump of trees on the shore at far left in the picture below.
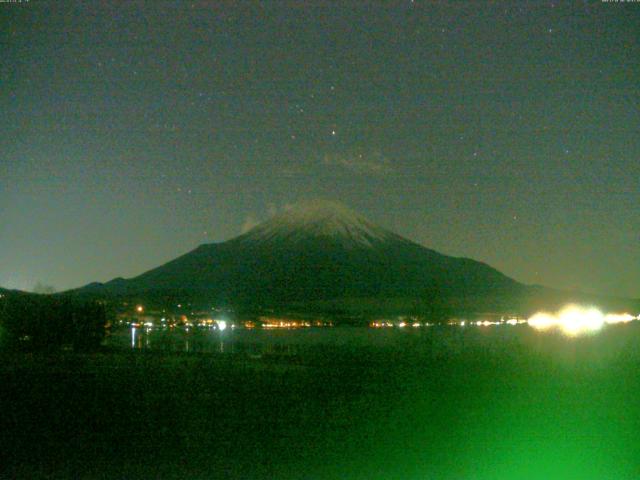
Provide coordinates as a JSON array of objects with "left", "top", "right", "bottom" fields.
[{"left": 0, "top": 294, "right": 107, "bottom": 351}]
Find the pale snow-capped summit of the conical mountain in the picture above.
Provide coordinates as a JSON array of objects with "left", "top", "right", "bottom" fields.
[{"left": 236, "top": 200, "right": 396, "bottom": 247}]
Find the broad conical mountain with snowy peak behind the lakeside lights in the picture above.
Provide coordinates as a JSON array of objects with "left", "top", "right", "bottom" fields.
[{"left": 76, "top": 202, "right": 636, "bottom": 316}]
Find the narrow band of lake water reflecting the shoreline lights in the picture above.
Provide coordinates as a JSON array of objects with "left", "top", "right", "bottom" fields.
[{"left": 112, "top": 318, "right": 640, "bottom": 359}]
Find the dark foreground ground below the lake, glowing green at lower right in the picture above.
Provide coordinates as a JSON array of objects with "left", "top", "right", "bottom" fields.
[{"left": 0, "top": 326, "right": 640, "bottom": 480}]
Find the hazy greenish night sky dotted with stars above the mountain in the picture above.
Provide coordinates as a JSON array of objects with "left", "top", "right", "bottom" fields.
[{"left": 0, "top": 0, "right": 640, "bottom": 297}]
